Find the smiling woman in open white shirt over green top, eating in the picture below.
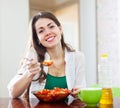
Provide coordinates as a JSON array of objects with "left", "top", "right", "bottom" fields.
[{"left": 8, "top": 12, "right": 86, "bottom": 98}]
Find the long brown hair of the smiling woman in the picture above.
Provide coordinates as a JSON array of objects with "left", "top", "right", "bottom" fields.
[{"left": 30, "top": 11, "right": 74, "bottom": 82}]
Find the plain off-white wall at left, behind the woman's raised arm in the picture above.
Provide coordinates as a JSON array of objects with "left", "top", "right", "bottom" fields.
[{"left": 0, "top": 0, "right": 29, "bottom": 97}]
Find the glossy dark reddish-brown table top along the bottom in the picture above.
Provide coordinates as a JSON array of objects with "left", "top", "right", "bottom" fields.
[{"left": 0, "top": 98, "right": 120, "bottom": 108}]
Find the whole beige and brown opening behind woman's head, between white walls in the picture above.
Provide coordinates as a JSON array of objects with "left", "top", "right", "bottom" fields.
[{"left": 30, "top": 0, "right": 80, "bottom": 50}]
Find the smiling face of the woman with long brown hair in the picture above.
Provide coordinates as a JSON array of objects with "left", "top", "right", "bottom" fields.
[{"left": 35, "top": 18, "right": 62, "bottom": 48}]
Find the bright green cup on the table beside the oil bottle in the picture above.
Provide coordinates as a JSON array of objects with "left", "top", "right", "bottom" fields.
[{"left": 78, "top": 88, "right": 102, "bottom": 106}]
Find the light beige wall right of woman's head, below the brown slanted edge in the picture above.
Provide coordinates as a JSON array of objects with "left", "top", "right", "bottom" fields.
[{"left": 54, "top": 3, "right": 80, "bottom": 50}]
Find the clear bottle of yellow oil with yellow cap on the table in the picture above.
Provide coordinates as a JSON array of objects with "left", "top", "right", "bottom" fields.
[{"left": 99, "top": 53, "right": 113, "bottom": 104}]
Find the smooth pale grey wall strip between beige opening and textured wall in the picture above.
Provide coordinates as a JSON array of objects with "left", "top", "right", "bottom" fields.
[{"left": 79, "top": 0, "right": 97, "bottom": 86}]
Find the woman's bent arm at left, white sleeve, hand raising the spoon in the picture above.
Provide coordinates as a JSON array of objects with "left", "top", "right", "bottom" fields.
[{"left": 8, "top": 60, "right": 41, "bottom": 98}]
